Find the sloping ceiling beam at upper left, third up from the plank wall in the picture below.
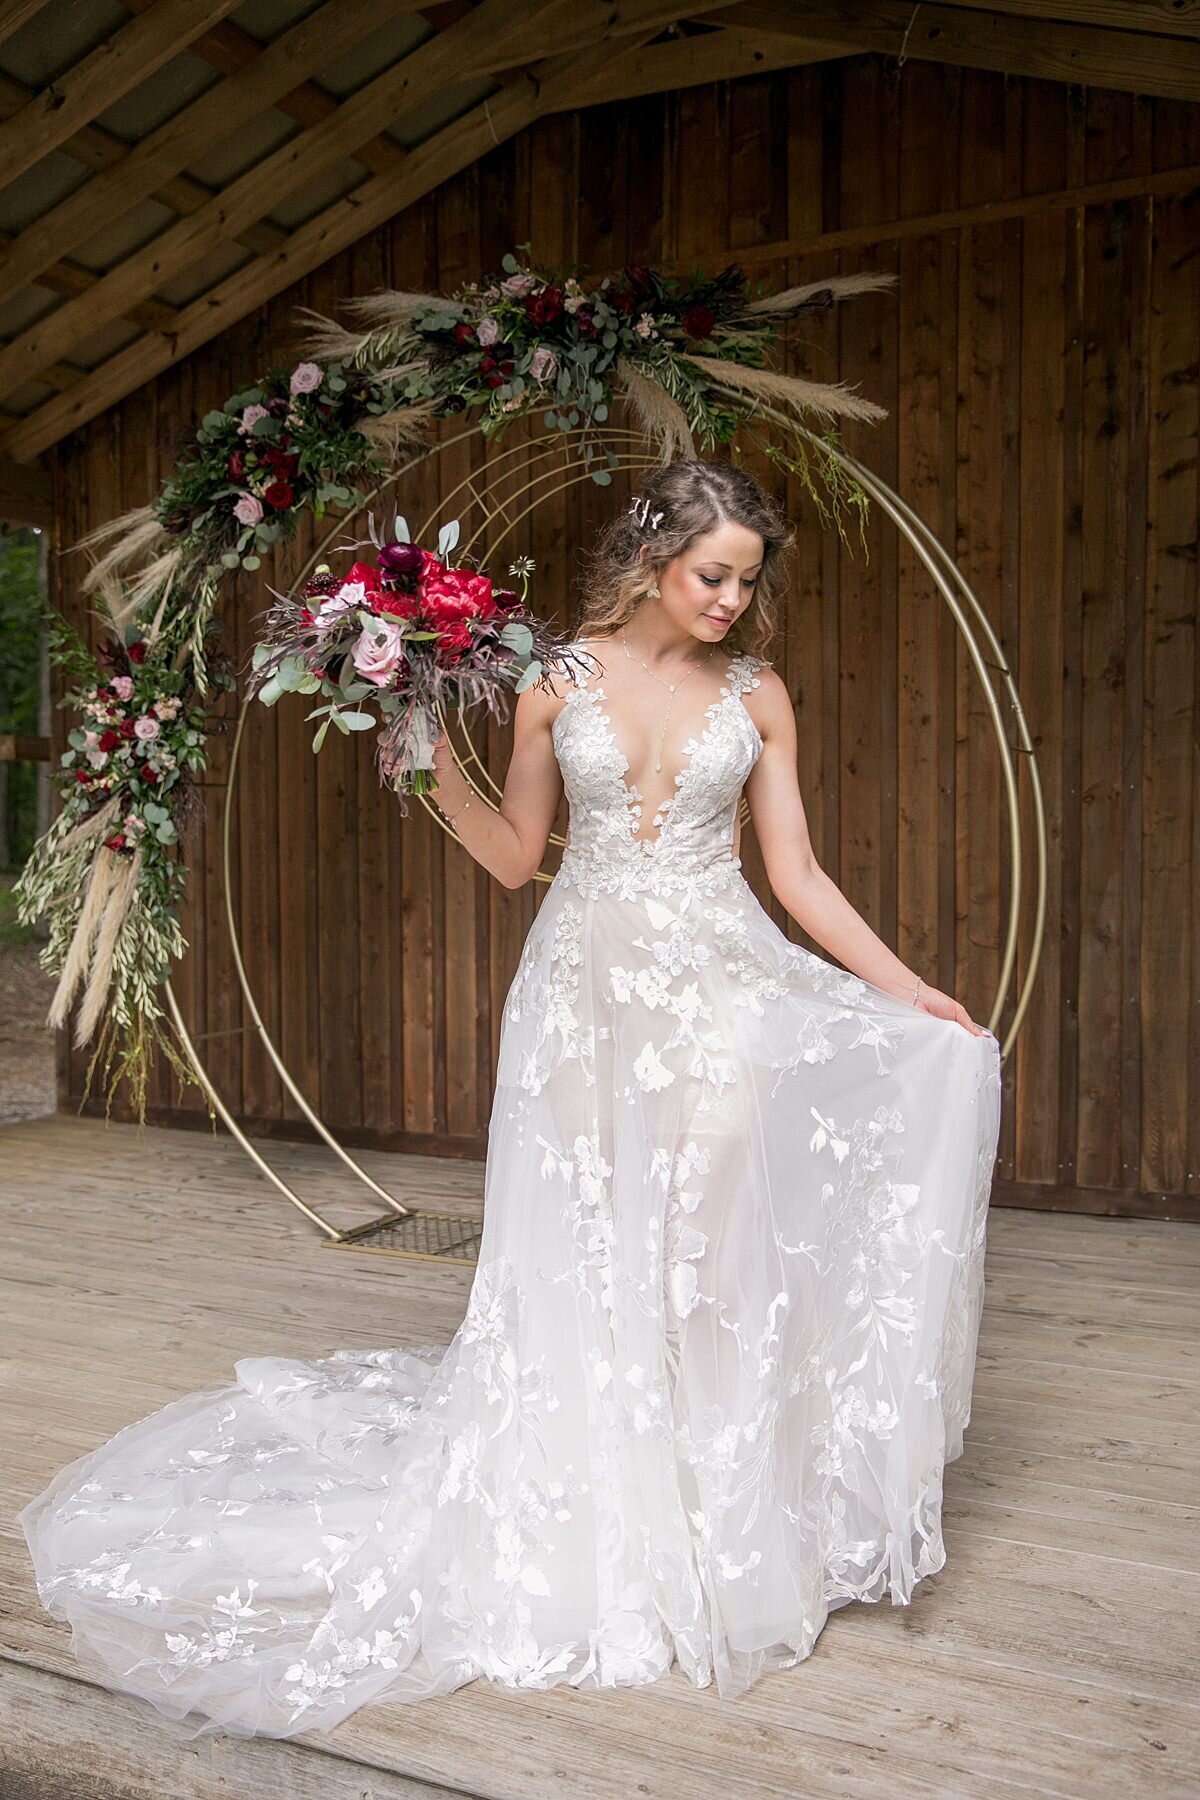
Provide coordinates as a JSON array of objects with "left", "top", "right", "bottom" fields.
[{"left": 0, "top": 0, "right": 412, "bottom": 301}]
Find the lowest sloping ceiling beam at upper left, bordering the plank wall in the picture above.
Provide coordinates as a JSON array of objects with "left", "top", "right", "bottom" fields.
[{"left": 0, "top": 23, "right": 676, "bottom": 463}]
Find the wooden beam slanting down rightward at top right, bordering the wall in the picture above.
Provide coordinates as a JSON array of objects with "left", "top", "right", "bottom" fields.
[{"left": 705, "top": 0, "right": 1200, "bottom": 101}]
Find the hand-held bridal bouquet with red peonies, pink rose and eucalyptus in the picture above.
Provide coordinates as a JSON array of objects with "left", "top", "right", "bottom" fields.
[{"left": 248, "top": 517, "right": 581, "bottom": 805}]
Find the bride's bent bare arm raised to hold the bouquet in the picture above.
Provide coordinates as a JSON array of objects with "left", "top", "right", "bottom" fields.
[{"left": 417, "top": 688, "right": 563, "bottom": 887}]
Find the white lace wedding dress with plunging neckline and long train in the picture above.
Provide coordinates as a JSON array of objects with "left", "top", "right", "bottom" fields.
[{"left": 20, "top": 640, "right": 1000, "bottom": 1737}]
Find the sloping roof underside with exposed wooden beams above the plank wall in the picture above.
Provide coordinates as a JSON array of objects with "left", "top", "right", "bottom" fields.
[{"left": 0, "top": 0, "right": 1200, "bottom": 463}]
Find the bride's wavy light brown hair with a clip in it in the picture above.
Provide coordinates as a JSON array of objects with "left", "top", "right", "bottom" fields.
[{"left": 576, "top": 457, "right": 795, "bottom": 655}]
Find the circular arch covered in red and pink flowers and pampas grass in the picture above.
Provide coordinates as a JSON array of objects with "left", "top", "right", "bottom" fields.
[{"left": 16, "top": 245, "right": 1045, "bottom": 1195}]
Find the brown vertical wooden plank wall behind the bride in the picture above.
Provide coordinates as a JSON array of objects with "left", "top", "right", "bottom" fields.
[{"left": 47, "top": 58, "right": 1200, "bottom": 1217}]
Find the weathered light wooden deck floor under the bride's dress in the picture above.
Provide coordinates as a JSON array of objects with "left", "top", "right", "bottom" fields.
[{"left": 0, "top": 1116, "right": 1200, "bottom": 1800}]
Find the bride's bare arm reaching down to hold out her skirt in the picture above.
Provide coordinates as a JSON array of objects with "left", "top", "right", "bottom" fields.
[{"left": 747, "top": 670, "right": 982, "bottom": 1037}]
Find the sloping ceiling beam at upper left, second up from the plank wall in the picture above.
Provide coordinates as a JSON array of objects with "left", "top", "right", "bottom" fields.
[{"left": 0, "top": 0, "right": 734, "bottom": 406}]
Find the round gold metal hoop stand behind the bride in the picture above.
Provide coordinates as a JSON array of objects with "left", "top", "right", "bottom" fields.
[{"left": 166, "top": 421, "right": 1047, "bottom": 1264}]
